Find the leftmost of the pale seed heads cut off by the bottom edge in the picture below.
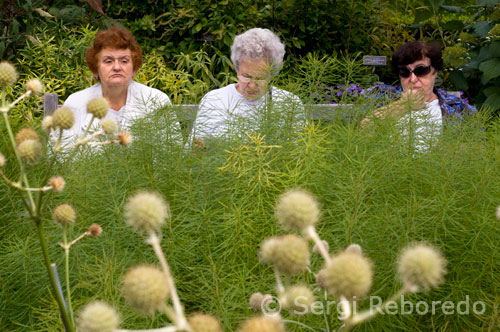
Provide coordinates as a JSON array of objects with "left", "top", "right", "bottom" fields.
[{"left": 77, "top": 301, "right": 120, "bottom": 332}]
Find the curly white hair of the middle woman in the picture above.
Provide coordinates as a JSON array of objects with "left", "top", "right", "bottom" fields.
[{"left": 231, "top": 28, "right": 285, "bottom": 76}]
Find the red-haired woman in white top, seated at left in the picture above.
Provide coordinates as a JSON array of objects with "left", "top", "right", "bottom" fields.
[{"left": 64, "top": 27, "right": 171, "bottom": 137}]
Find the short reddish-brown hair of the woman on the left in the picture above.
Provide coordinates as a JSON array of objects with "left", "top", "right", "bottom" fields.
[{"left": 85, "top": 26, "right": 142, "bottom": 74}]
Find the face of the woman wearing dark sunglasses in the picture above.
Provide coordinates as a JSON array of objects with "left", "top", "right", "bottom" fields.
[{"left": 399, "top": 57, "right": 438, "bottom": 101}]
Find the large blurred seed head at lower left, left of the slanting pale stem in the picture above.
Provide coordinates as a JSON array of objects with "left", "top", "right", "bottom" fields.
[{"left": 122, "top": 265, "right": 170, "bottom": 315}]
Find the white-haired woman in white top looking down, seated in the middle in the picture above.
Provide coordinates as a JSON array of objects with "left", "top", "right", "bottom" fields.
[{"left": 193, "top": 28, "right": 303, "bottom": 145}]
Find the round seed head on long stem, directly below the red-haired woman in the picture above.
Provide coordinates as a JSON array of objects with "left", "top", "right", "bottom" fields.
[{"left": 125, "top": 192, "right": 170, "bottom": 232}]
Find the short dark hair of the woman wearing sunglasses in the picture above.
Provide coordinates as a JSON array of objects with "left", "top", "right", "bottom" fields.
[{"left": 391, "top": 40, "right": 443, "bottom": 75}]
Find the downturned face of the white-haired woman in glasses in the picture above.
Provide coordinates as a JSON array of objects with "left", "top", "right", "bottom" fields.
[{"left": 236, "top": 57, "right": 271, "bottom": 101}]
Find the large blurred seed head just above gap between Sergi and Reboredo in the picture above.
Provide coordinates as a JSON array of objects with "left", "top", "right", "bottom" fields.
[{"left": 316, "top": 251, "right": 373, "bottom": 299}]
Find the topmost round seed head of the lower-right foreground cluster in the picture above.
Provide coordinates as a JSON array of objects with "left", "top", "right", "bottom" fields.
[{"left": 276, "top": 190, "right": 320, "bottom": 231}]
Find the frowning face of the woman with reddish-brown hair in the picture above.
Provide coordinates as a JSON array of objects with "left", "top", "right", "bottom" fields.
[{"left": 97, "top": 48, "right": 136, "bottom": 88}]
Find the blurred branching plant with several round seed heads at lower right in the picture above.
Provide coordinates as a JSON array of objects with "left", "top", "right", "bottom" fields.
[{"left": 250, "top": 190, "right": 446, "bottom": 331}]
